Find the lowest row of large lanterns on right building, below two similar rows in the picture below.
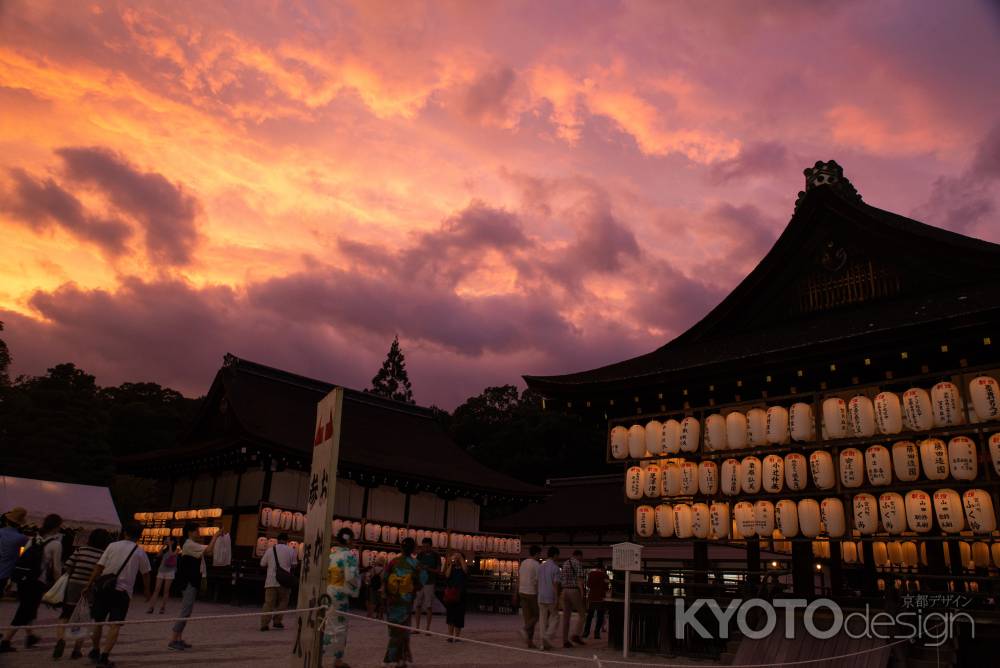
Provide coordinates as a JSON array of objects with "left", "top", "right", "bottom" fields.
[{"left": 635, "top": 489, "right": 996, "bottom": 540}]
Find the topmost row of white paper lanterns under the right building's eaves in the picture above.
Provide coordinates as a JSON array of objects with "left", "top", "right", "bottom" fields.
[{"left": 611, "top": 376, "right": 1000, "bottom": 459}]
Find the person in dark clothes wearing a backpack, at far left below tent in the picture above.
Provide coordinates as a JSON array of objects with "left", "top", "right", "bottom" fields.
[{"left": 0, "top": 514, "right": 62, "bottom": 652}]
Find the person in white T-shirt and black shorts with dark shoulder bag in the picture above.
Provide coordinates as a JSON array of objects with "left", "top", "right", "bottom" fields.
[{"left": 80, "top": 522, "right": 152, "bottom": 668}]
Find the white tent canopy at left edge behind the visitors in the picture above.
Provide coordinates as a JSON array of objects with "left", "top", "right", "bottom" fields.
[{"left": 0, "top": 476, "right": 121, "bottom": 531}]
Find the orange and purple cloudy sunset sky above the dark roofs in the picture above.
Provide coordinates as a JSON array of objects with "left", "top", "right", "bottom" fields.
[{"left": 0, "top": 0, "right": 1000, "bottom": 408}]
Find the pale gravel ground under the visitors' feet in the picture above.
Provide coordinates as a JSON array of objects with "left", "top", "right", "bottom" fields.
[{"left": 0, "top": 600, "right": 704, "bottom": 668}]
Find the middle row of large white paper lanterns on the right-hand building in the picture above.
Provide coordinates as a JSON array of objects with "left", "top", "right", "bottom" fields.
[{"left": 625, "top": 433, "right": 1000, "bottom": 500}]
